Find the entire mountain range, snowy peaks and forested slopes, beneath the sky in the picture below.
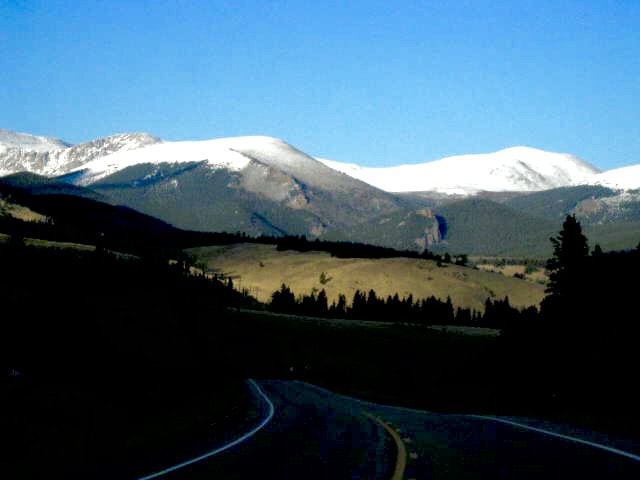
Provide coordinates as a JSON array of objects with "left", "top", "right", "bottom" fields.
[{"left": 0, "top": 130, "right": 640, "bottom": 256}]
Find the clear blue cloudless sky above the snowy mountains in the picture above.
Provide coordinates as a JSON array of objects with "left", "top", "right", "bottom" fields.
[{"left": 0, "top": 0, "right": 640, "bottom": 169}]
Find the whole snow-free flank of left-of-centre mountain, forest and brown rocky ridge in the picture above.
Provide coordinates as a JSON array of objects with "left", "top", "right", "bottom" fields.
[{"left": 84, "top": 156, "right": 435, "bottom": 250}]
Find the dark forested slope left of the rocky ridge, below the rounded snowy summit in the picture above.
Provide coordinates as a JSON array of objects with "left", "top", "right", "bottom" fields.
[{"left": 92, "top": 162, "right": 322, "bottom": 235}]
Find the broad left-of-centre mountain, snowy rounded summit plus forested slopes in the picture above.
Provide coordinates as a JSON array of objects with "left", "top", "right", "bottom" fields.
[{"left": 61, "top": 136, "right": 424, "bottom": 246}]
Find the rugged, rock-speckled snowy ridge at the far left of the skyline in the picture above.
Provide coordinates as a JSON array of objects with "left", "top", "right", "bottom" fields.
[{"left": 0, "top": 130, "right": 161, "bottom": 176}]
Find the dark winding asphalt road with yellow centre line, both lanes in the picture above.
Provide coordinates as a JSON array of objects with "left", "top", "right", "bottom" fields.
[{"left": 138, "top": 380, "right": 640, "bottom": 480}]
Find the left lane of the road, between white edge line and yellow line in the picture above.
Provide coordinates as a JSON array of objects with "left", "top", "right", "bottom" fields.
[{"left": 142, "top": 381, "right": 395, "bottom": 480}]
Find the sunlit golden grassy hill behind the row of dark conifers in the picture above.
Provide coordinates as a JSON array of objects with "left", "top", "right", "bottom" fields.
[{"left": 189, "top": 244, "right": 544, "bottom": 309}]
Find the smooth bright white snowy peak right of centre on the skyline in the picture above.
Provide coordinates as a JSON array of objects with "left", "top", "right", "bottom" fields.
[{"left": 321, "top": 147, "right": 601, "bottom": 195}]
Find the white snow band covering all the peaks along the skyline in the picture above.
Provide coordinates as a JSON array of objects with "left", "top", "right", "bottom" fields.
[{"left": 0, "top": 129, "right": 640, "bottom": 195}]
